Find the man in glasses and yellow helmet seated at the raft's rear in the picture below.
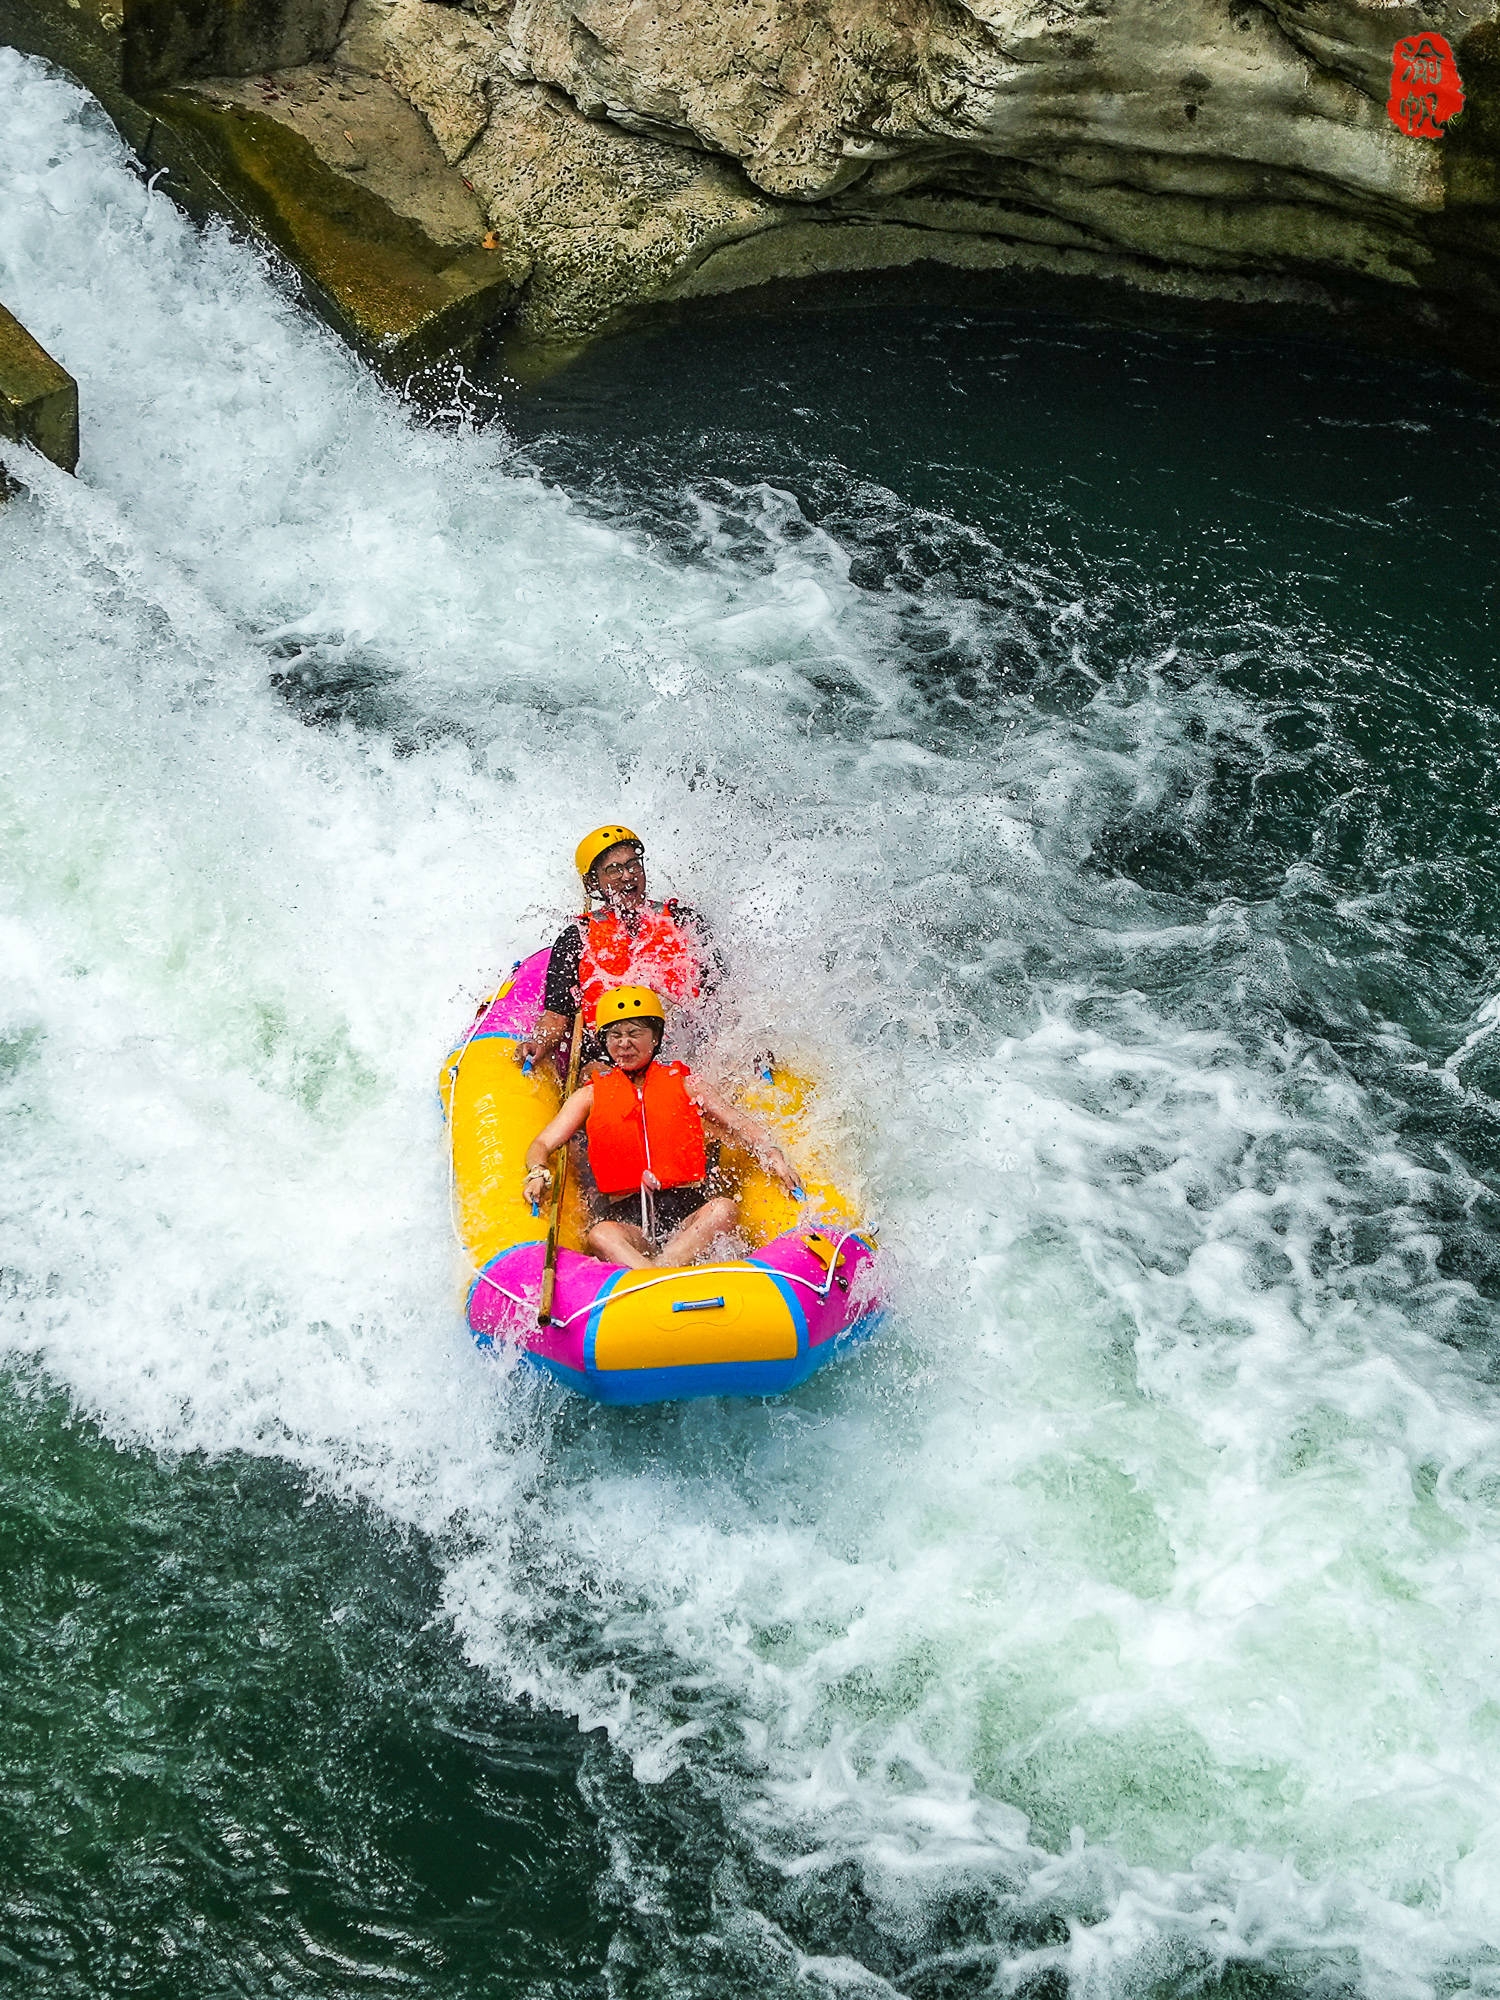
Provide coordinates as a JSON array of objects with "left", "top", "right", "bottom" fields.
[{"left": 516, "top": 826, "right": 724, "bottom": 1062}]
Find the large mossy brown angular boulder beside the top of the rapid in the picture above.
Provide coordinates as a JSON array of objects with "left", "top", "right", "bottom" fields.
[{"left": 0, "top": 0, "right": 520, "bottom": 380}]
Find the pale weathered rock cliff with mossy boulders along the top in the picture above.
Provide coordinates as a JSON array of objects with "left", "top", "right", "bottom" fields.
[{"left": 0, "top": 0, "right": 1500, "bottom": 368}]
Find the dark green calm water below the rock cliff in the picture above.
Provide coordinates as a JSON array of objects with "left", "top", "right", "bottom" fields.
[{"left": 510, "top": 306, "right": 1500, "bottom": 1248}]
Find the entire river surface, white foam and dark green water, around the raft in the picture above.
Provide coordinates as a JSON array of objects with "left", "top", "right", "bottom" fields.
[{"left": 0, "top": 52, "right": 1500, "bottom": 2000}]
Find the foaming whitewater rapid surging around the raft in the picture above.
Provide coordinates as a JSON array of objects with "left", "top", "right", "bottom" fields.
[{"left": 0, "top": 50, "right": 1500, "bottom": 2000}]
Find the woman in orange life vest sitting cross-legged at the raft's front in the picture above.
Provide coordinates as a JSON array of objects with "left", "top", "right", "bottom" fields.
[{"left": 522, "top": 986, "right": 796, "bottom": 1270}]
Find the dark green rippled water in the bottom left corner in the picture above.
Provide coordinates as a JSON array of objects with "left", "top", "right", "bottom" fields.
[{"left": 0, "top": 1380, "right": 614, "bottom": 1996}]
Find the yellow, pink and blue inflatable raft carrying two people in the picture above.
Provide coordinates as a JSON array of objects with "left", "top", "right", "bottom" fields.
[{"left": 442, "top": 952, "right": 880, "bottom": 1404}]
